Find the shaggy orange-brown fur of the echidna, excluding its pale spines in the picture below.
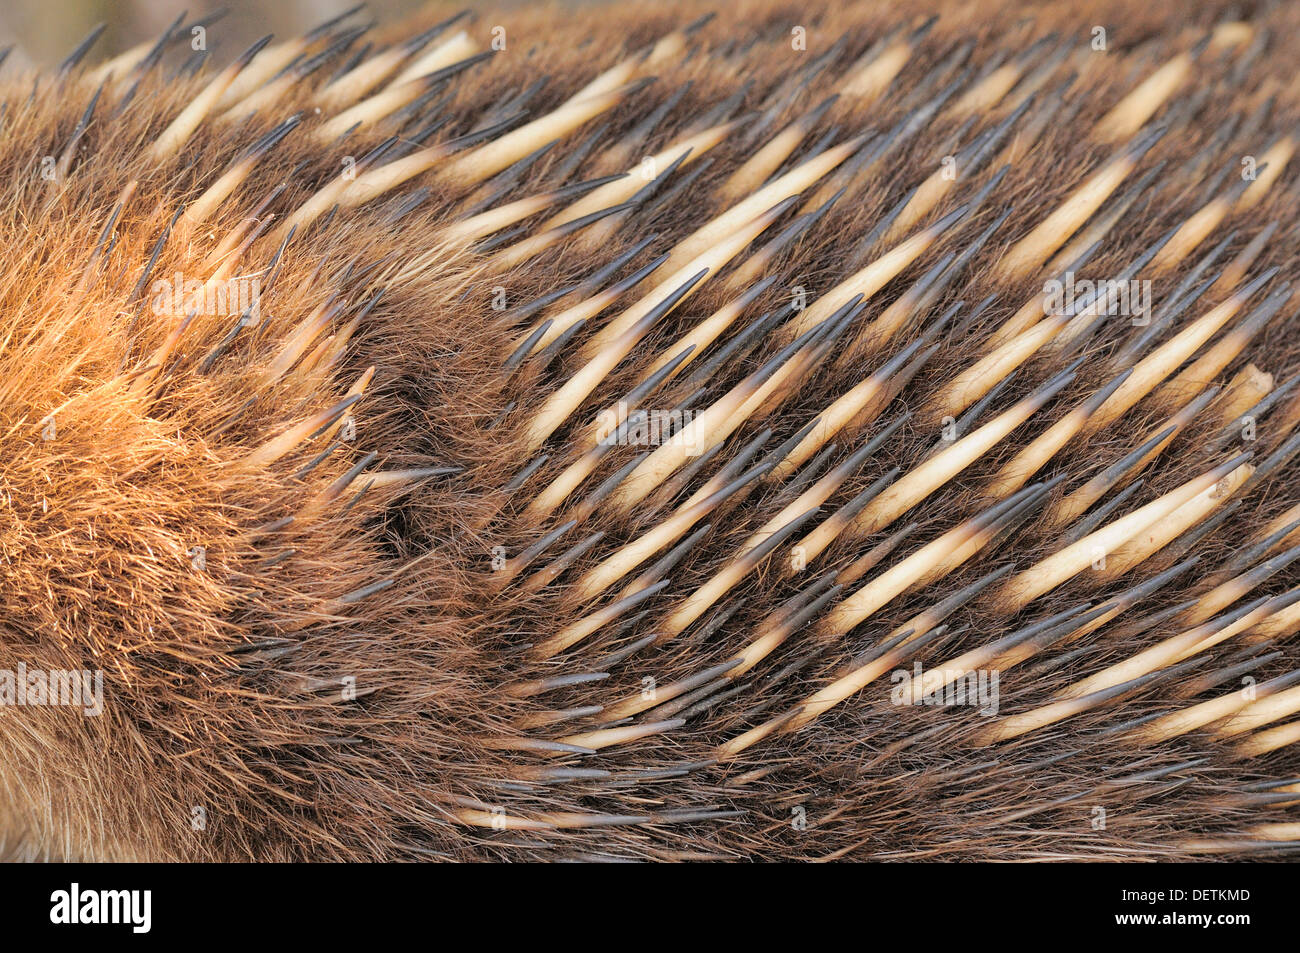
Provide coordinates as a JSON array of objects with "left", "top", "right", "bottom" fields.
[{"left": 0, "top": 0, "right": 1300, "bottom": 861}]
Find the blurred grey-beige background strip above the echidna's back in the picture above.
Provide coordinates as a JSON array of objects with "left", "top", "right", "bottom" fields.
[{"left": 0, "top": 0, "right": 457, "bottom": 68}]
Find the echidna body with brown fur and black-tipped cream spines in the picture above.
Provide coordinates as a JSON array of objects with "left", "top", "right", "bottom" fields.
[{"left": 0, "top": 0, "right": 1300, "bottom": 861}]
